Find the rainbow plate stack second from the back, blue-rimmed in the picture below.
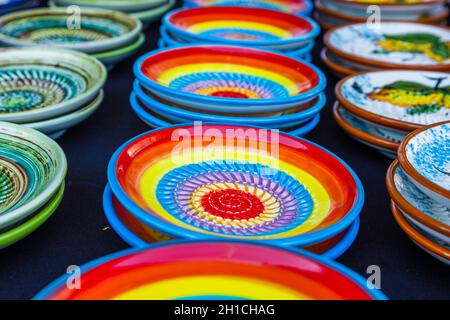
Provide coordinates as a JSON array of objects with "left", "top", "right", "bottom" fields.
[{"left": 159, "top": 6, "right": 320, "bottom": 60}]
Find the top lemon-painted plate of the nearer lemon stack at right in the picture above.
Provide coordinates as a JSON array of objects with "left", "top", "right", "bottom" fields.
[{"left": 335, "top": 70, "right": 450, "bottom": 132}]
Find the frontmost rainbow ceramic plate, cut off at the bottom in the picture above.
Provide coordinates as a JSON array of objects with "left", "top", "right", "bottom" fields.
[{"left": 34, "top": 241, "right": 386, "bottom": 300}]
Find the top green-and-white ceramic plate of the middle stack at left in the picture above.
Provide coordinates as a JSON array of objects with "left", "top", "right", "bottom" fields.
[{"left": 0, "top": 48, "right": 107, "bottom": 123}]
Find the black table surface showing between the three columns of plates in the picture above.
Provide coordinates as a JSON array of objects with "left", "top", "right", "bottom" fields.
[{"left": 0, "top": 2, "right": 450, "bottom": 299}]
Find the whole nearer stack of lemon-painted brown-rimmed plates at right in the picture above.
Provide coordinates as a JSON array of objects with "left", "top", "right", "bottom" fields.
[{"left": 334, "top": 70, "right": 450, "bottom": 158}]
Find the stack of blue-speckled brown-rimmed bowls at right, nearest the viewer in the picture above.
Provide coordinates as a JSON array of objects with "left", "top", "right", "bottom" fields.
[{"left": 386, "top": 121, "right": 450, "bottom": 265}]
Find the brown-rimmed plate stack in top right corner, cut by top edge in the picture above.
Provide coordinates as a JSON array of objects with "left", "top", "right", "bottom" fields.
[{"left": 315, "top": 0, "right": 449, "bottom": 29}]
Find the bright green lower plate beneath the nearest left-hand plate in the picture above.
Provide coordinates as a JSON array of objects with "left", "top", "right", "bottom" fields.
[{"left": 0, "top": 183, "right": 64, "bottom": 249}]
